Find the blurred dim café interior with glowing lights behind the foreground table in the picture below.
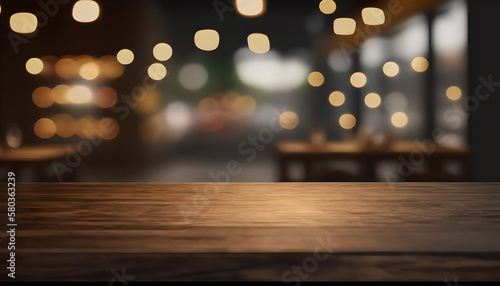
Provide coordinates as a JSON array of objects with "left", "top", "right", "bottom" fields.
[{"left": 0, "top": 0, "right": 500, "bottom": 182}]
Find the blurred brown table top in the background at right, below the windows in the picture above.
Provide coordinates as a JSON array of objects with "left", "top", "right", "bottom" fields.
[{"left": 276, "top": 141, "right": 470, "bottom": 155}]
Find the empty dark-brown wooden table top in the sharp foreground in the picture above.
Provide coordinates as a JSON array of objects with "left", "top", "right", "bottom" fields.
[{"left": 0, "top": 183, "right": 500, "bottom": 281}]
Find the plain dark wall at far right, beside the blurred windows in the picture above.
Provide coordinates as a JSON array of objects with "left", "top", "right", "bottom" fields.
[{"left": 468, "top": 0, "right": 500, "bottom": 181}]
